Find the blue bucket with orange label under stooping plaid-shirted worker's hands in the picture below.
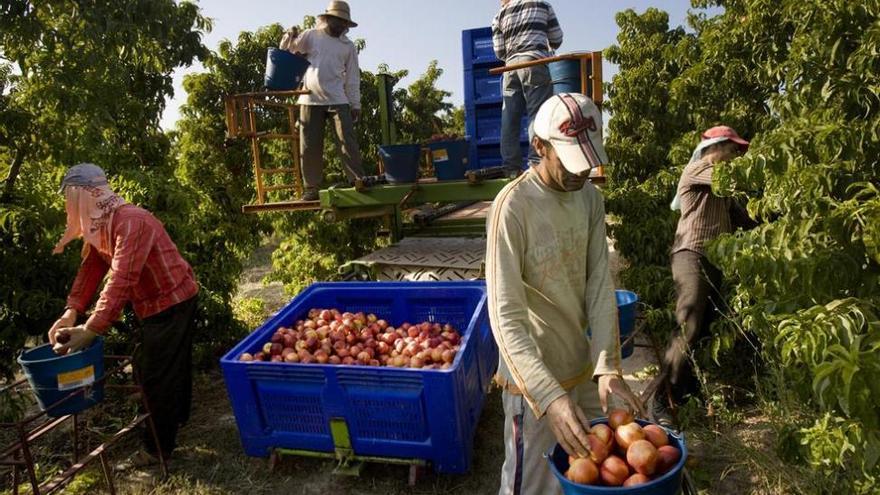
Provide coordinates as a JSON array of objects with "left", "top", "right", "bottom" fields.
[{"left": 18, "top": 337, "right": 104, "bottom": 418}]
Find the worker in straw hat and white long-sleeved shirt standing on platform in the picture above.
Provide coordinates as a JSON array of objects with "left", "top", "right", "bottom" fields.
[{"left": 280, "top": 1, "right": 364, "bottom": 201}]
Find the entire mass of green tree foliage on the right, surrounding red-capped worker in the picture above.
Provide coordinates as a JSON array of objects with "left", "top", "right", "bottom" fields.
[{"left": 608, "top": 0, "right": 880, "bottom": 493}]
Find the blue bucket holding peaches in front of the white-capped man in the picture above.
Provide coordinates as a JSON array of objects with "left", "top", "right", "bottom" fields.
[{"left": 544, "top": 418, "right": 687, "bottom": 495}]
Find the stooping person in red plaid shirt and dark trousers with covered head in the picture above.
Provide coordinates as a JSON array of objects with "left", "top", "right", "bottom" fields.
[{"left": 49, "top": 164, "right": 199, "bottom": 467}]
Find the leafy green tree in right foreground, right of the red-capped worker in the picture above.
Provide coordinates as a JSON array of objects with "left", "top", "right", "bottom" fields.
[{"left": 712, "top": 2, "right": 880, "bottom": 484}]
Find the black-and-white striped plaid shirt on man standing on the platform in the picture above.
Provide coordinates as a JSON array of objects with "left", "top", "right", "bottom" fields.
[{"left": 492, "top": 0, "right": 562, "bottom": 62}]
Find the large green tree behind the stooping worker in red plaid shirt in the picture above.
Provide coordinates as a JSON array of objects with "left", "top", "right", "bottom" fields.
[{"left": 0, "top": 0, "right": 210, "bottom": 375}]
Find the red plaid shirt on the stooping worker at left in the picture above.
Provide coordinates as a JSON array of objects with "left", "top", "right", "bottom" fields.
[{"left": 67, "top": 205, "right": 199, "bottom": 334}]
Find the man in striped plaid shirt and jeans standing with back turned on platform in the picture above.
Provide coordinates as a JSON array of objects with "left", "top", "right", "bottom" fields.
[{"left": 492, "top": 0, "right": 562, "bottom": 170}]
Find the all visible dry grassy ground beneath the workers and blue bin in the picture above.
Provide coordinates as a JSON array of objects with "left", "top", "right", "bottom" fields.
[{"left": 0, "top": 238, "right": 812, "bottom": 495}]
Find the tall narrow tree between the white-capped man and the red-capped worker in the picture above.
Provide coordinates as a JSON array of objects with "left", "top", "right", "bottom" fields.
[{"left": 605, "top": 9, "right": 697, "bottom": 335}]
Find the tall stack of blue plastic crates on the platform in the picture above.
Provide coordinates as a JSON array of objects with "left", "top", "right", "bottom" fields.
[{"left": 461, "top": 27, "right": 529, "bottom": 169}]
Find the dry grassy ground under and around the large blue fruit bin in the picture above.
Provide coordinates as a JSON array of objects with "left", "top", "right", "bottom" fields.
[{"left": 119, "top": 373, "right": 503, "bottom": 495}]
